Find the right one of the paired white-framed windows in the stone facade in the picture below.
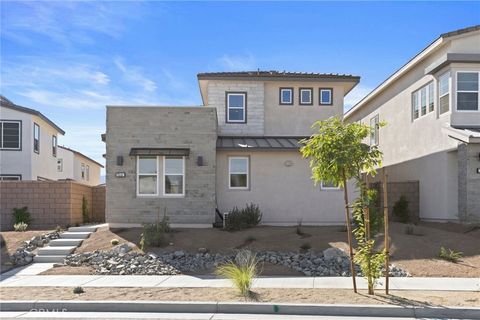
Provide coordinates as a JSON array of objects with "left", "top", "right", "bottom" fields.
[{"left": 163, "top": 156, "right": 185, "bottom": 196}]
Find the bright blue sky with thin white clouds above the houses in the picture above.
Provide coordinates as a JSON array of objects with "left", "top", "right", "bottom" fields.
[{"left": 1, "top": 1, "right": 480, "bottom": 170}]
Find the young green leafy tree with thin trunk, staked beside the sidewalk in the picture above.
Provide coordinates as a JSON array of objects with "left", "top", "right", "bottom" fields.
[{"left": 300, "top": 117, "right": 382, "bottom": 294}]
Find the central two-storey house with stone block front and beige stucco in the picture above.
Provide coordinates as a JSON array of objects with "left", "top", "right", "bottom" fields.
[{"left": 104, "top": 71, "right": 359, "bottom": 227}]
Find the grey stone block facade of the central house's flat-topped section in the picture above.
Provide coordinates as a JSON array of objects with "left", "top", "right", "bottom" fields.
[{"left": 106, "top": 107, "right": 217, "bottom": 226}]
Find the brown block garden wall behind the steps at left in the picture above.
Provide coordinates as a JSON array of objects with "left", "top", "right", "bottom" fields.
[{"left": 0, "top": 181, "right": 105, "bottom": 230}]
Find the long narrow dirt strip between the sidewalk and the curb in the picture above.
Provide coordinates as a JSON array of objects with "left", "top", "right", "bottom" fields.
[{"left": 0, "top": 287, "right": 480, "bottom": 307}]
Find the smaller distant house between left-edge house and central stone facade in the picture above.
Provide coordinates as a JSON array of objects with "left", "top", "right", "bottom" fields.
[{"left": 57, "top": 146, "right": 103, "bottom": 186}]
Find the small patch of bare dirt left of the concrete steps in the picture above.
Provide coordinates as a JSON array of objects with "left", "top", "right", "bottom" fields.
[{"left": 0, "top": 230, "right": 51, "bottom": 273}]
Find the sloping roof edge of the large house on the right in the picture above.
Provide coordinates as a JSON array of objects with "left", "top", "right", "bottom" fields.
[{"left": 345, "top": 25, "right": 480, "bottom": 119}]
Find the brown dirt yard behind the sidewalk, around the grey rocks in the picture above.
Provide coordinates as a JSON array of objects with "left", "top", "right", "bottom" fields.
[{"left": 45, "top": 223, "right": 480, "bottom": 277}]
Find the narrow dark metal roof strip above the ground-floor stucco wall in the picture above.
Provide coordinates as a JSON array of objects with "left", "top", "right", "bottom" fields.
[{"left": 217, "top": 136, "right": 307, "bottom": 151}]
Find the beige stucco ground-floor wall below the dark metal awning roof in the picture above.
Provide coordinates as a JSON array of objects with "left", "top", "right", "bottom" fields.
[{"left": 216, "top": 151, "right": 353, "bottom": 225}]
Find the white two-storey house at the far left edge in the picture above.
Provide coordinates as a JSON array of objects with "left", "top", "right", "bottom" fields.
[{"left": 0, "top": 96, "right": 65, "bottom": 181}]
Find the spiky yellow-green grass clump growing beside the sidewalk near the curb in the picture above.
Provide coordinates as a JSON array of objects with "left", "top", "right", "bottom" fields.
[{"left": 215, "top": 250, "right": 258, "bottom": 298}]
